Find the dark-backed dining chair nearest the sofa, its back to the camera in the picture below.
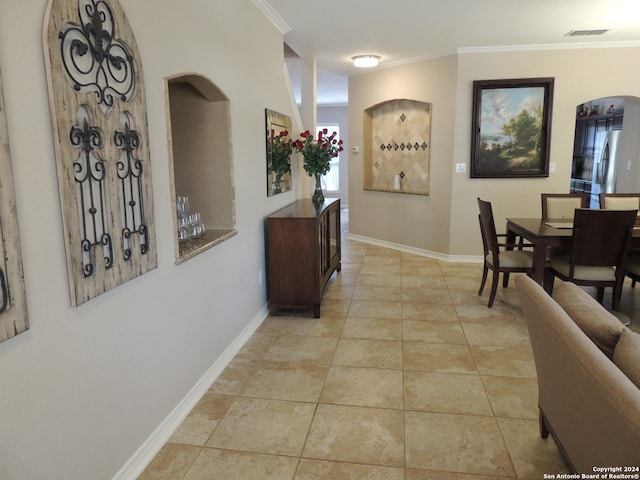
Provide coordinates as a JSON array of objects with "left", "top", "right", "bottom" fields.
[{"left": 544, "top": 208, "right": 637, "bottom": 310}]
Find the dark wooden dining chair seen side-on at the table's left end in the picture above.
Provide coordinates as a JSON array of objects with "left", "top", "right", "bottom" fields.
[{"left": 478, "top": 198, "right": 533, "bottom": 308}]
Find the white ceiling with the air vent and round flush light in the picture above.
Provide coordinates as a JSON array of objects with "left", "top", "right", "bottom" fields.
[{"left": 252, "top": 0, "right": 640, "bottom": 105}]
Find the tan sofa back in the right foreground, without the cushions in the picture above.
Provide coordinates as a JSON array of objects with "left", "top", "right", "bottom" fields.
[{"left": 516, "top": 276, "right": 640, "bottom": 473}]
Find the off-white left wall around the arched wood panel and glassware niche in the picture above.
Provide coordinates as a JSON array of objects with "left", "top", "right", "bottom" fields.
[{"left": 0, "top": 0, "right": 296, "bottom": 480}]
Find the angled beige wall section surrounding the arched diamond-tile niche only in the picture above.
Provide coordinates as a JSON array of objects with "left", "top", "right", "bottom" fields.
[{"left": 349, "top": 56, "right": 457, "bottom": 252}]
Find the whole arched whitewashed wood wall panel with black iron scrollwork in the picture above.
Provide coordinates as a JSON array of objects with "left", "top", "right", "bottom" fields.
[{"left": 44, "top": 0, "right": 157, "bottom": 306}]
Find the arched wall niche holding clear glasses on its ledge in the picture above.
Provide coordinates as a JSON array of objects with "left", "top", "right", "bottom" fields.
[{"left": 165, "top": 73, "right": 237, "bottom": 263}]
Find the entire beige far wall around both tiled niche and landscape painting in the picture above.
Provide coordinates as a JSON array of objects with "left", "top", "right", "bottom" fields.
[{"left": 349, "top": 48, "right": 640, "bottom": 260}]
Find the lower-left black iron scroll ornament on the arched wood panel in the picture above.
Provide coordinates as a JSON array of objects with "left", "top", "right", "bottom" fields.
[{"left": 70, "top": 106, "right": 113, "bottom": 277}]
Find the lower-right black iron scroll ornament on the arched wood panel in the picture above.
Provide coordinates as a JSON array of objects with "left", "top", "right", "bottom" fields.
[{"left": 113, "top": 112, "right": 149, "bottom": 260}]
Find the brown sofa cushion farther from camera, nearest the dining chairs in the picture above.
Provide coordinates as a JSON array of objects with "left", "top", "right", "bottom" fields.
[{"left": 553, "top": 282, "right": 624, "bottom": 358}]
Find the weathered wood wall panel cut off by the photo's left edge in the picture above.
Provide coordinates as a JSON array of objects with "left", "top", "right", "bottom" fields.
[{"left": 0, "top": 68, "right": 29, "bottom": 342}]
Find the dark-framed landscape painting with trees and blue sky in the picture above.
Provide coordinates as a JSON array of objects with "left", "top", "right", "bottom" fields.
[{"left": 471, "top": 78, "right": 554, "bottom": 178}]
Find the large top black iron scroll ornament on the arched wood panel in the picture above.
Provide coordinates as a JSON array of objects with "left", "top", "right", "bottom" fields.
[{"left": 59, "top": 0, "right": 136, "bottom": 111}]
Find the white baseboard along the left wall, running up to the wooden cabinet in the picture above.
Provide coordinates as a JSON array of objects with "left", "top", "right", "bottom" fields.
[{"left": 113, "top": 305, "right": 269, "bottom": 480}]
